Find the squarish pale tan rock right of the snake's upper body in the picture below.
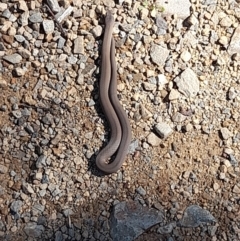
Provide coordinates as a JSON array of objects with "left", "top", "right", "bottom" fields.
[{"left": 150, "top": 44, "right": 169, "bottom": 66}]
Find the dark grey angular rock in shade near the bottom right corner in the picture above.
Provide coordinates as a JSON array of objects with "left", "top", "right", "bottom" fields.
[{"left": 177, "top": 205, "right": 216, "bottom": 228}]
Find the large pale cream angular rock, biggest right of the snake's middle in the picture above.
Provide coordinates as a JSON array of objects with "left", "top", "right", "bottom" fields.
[{"left": 174, "top": 68, "right": 199, "bottom": 97}]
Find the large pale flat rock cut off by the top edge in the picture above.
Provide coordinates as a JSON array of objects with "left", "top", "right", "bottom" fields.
[{"left": 156, "top": 0, "right": 191, "bottom": 19}]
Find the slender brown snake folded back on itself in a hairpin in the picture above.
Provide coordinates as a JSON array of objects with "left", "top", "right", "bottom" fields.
[{"left": 96, "top": 11, "right": 132, "bottom": 174}]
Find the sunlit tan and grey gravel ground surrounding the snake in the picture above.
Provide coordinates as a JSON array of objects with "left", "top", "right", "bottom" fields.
[{"left": 0, "top": 0, "right": 240, "bottom": 241}]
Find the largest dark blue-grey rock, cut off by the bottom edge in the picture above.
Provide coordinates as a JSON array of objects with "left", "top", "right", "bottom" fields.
[{"left": 110, "top": 201, "right": 164, "bottom": 241}]
